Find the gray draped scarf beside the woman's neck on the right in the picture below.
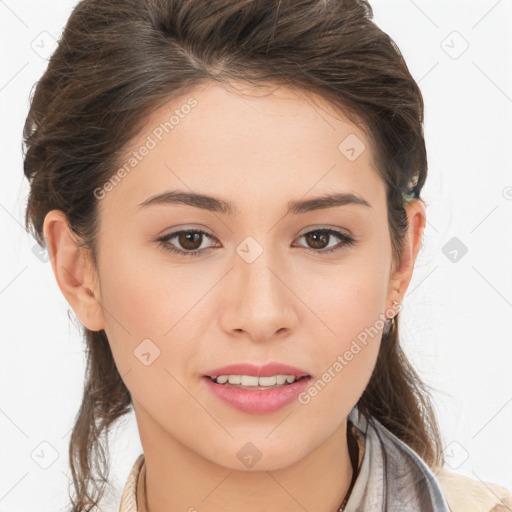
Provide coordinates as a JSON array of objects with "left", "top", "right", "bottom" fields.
[{"left": 344, "top": 407, "right": 450, "bottom": 512}]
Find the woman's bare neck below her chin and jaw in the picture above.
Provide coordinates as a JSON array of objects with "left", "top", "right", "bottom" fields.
[{"left": 137, "top": 402, "right": 353, "bottom": 512}]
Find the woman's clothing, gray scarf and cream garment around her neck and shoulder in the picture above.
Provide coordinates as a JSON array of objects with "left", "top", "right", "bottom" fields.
[{"left": 119, "top": 407, "right": 512, "bottom": 512}]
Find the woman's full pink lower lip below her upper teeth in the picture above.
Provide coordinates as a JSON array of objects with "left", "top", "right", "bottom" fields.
[{"left": 204, "top": 377, "right": 311, "bottom": 414}]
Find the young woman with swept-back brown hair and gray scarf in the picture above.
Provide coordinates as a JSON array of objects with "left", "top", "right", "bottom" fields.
[{"left": 24, "top": 0, "right": 512, "bottom": 512}]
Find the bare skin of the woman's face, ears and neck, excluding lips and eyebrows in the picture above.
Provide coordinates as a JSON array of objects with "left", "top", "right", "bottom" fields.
[{"left": 44, "top": 84, "right": 425, "bottom": 512}]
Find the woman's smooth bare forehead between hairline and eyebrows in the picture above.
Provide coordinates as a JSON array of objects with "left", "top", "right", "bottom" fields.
[{"left": 102, "top": 83, "right": 384, "bottom": 217}]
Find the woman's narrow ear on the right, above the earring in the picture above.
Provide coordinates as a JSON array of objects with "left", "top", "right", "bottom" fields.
[{"left": 388, "top": 199, "right": 427, "bottom": 307}]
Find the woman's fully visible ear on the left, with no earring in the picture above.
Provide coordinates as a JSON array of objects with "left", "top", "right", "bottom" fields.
[{"left": 43, "top": 210, "right": 104, "bottom": 331}]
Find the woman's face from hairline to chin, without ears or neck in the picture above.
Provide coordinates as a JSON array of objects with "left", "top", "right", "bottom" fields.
[{"left": 74, "top": 84, "right": 416, "bottom": 470}]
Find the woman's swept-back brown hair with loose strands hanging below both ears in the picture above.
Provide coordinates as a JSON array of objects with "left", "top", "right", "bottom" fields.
[{"left": 24, "top": 0, "right": 444, "bottom": 512}]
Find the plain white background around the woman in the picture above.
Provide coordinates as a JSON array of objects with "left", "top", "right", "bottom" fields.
[{"left": 0, "top": 0, "right": 512, "bottom": 512}]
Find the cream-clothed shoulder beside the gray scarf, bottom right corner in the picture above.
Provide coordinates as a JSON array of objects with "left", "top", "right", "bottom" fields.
[{"left": 434, "top": 468, "right": 512, "bottom": 512}]
